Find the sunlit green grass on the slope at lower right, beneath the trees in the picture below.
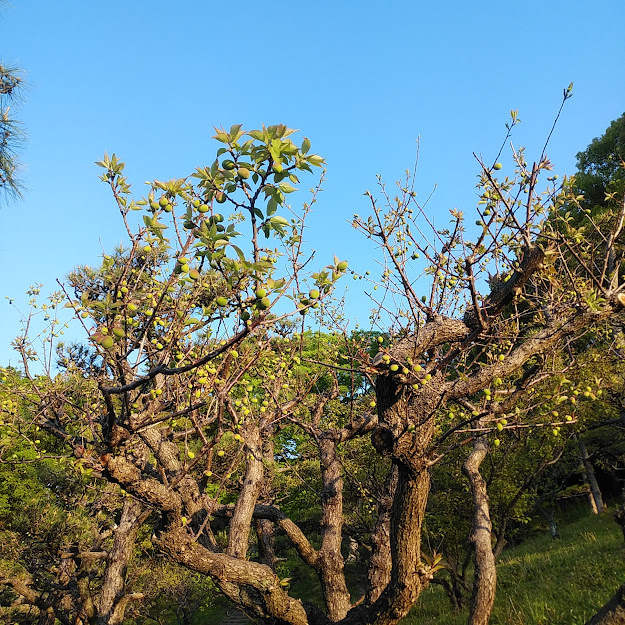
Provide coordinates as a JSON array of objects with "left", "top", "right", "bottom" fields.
[{"left": 402, "top": 513, "right": 625, "bottom": 625}]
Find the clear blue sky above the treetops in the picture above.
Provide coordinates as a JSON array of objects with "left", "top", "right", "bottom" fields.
[{"left": 0, "top": 0, "right": 625, "bottom": 364}]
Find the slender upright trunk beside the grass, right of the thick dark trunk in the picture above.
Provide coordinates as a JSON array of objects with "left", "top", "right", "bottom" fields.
[{"left": 462, "top": 437, "right": 497, "bottom": 625}]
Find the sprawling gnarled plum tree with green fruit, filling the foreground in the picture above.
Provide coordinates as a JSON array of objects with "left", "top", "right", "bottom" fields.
[{"left": 3, "top": 102, "right": 625, "bottom": 625}]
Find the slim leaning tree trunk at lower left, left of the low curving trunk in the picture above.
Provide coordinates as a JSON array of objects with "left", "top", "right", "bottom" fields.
[{"left": 96, "top": 499, "right": 143, "bottom": 625}]
